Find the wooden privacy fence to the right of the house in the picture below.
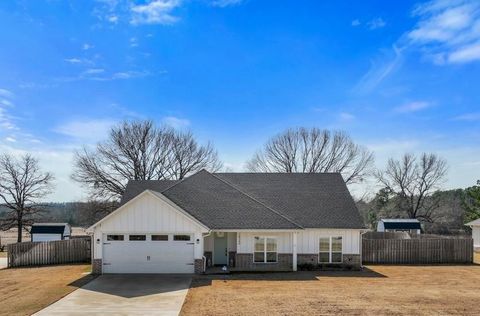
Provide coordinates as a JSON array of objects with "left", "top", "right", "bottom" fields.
[{"left": 362, "top": 236, "right": 473, "bottom": 264}]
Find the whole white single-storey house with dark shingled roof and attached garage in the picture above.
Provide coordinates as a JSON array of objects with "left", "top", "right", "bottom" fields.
[{"left": 88, "top": 170, "right": 363, "bottom": 273}]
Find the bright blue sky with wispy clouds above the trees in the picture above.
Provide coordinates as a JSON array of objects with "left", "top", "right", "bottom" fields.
[{"left": 0, "top": 0, "right": 480, "bottom": 201}]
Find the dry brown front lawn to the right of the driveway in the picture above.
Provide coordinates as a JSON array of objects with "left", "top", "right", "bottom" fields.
[{"left": 181, "top": 265, "right": 480, "bottom": 315}]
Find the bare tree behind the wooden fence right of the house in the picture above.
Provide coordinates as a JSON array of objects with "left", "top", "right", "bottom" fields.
[{"left": 375, "top": 153, "right": 448, "bottom": 222}]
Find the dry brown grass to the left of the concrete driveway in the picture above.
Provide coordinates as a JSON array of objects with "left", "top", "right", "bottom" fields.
[{"left": 0, "top": 264, "right": 93, "bottom": 315}]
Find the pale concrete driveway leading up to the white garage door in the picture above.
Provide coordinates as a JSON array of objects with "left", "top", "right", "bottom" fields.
[{"left": 35, "top": 274, "right": 191, "bottom": 315}]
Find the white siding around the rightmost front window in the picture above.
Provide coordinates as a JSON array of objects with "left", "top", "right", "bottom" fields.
[{"left": 297, "top": 229, "right": 360, "bottom": 254}]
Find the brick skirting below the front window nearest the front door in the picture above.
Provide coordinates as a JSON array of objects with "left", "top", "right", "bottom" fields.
[{"left": 235, "top": 253, "right": 292, "bottom": 271}]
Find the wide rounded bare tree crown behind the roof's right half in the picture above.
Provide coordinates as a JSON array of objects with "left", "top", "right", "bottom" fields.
[{"left": 247, "top": 128, "right": 374, "bottom": 184}]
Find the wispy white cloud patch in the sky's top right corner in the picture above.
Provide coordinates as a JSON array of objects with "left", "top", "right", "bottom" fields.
[{"left": 407, "top": 0, "right": 480, "bottom": 64}]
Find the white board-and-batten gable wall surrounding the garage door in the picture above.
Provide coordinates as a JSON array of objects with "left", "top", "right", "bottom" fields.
[{"left": 94, "top": 192, "right": 208, "bottom": 259}]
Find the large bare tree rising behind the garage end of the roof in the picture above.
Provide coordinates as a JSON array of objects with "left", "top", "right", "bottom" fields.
[{"left": 72, "top": 121, "right": 221, "bottom": 201}]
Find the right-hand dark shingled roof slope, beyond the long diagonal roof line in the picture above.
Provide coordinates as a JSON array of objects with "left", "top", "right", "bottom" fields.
[{"left": 216, "top": 173, "right": 363, "bottom": 228}]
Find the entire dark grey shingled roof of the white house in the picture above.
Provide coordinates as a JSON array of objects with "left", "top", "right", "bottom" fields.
[{"left": 122, "top": 170, "right": 364, "bottom": 229}]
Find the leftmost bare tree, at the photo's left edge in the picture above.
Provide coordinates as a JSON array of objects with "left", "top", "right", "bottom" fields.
[{"left": 0, "top": 154, "right": 53, "bottom": 242}]
